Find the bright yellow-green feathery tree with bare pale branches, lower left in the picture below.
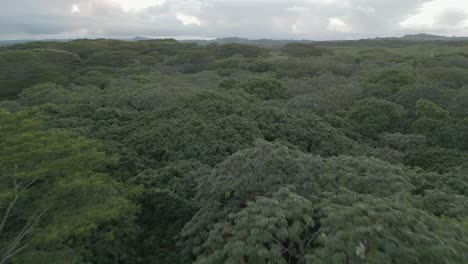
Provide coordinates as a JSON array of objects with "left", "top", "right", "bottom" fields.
[{"left": 0, "top": 110, "right": 138, "bottom": 263}]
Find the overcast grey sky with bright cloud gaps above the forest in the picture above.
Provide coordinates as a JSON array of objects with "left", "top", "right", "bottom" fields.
[{"left": 0, "top": 0, "right": 468, "bottom": 40}]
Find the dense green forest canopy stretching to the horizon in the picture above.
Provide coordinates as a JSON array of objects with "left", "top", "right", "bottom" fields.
[{"left": 0, "top": 39, "right": 468, "bottom": 264}]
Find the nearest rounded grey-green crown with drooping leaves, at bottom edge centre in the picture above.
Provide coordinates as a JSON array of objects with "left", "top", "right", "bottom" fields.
[{"left": 195, "top": 188, "right": 320, "bottom": 264}]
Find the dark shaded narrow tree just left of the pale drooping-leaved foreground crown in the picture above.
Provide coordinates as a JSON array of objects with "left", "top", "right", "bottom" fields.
[{"left": 131, "top": 161, "right": 211, "bottom": 263}]
